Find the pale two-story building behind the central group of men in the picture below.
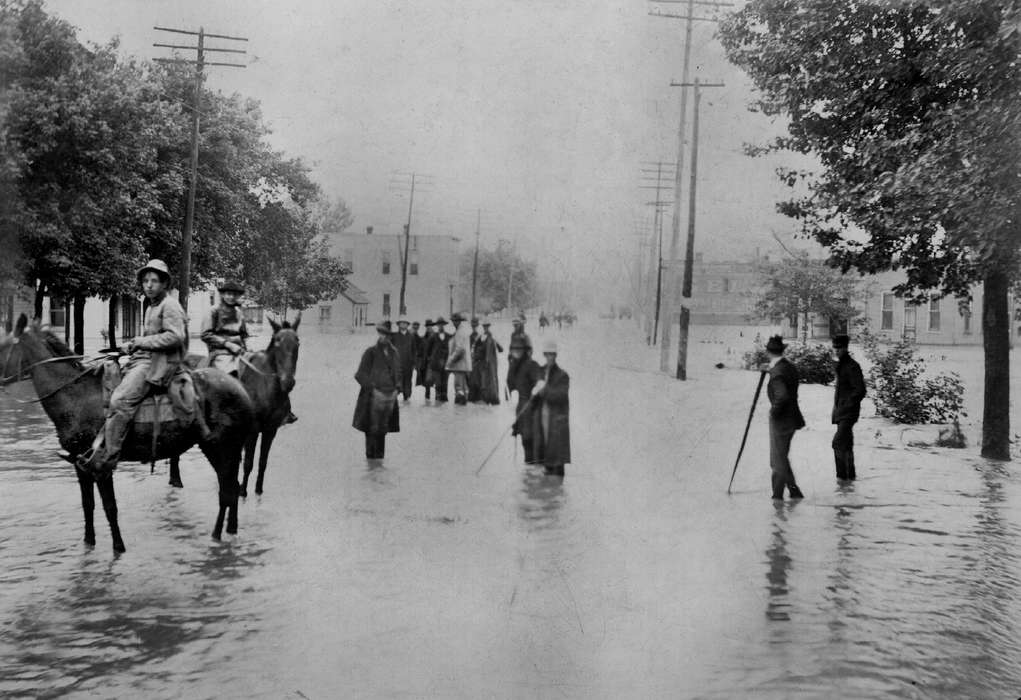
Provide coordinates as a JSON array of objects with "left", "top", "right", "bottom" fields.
[{"left": 320, "top": 227, "right": 460, "bottom": 329}]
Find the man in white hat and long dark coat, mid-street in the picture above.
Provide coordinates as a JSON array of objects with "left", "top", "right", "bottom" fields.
[{"left": 532, "top": 340, "right": 571, "bottom": 477}]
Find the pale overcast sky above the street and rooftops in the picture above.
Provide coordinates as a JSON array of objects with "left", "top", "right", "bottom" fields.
[{"left": 47, "top": 0, "right": 812, "bottom": 295}]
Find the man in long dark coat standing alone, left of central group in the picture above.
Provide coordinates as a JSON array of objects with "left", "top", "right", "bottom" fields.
[{"left": 351, "top": 320, "right": 400, "bottom": 459}]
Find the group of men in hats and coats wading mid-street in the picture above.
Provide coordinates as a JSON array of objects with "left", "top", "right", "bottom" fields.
[{"left": 352, "top": 313, "right": 571, "bottom": 477}]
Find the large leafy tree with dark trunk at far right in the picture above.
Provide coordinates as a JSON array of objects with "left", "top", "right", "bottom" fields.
[{"left": 721, "top": 0, "right": 1021, "bottom": 459}]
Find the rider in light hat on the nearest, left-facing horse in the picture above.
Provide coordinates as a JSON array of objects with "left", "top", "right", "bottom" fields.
[{"left": 81, "top": 259, "right": 188, "bottom": 473}]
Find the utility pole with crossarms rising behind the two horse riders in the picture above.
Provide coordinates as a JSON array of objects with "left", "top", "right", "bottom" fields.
[{"left": 152, "top": 27, "right": 248, "bottom": 324}]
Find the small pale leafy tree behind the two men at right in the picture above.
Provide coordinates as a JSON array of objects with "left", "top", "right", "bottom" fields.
[{"left": 755, "top": 254, "right": 860, "bottom": 343}]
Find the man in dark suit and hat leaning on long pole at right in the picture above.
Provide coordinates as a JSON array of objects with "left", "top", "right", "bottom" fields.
[{"left": 766, "top": 336, "right": 805, "bottom": 500}]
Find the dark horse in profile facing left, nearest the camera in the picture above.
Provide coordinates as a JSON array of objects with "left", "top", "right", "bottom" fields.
[{"left": 0, "top": 314, "right": 254, "bottom": 552}]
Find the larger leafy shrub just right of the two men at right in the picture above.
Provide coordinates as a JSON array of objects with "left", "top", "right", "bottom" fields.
[{"left": 862, "top": 333, "right": 965, "bottom": 423}]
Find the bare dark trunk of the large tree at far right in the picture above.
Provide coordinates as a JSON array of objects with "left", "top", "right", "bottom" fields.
[{"left": 982, "top": 271, "right": 1011, "bottom": 460}]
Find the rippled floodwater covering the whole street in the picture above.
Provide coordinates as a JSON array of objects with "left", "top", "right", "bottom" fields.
[{"left": 0, "top": 318, "right": 1021, "bottom": 699}]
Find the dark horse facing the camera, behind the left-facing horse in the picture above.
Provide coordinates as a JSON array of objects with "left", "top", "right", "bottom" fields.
[{"left": 171, "top": 312, "right": 301, "bottom": 496}]
